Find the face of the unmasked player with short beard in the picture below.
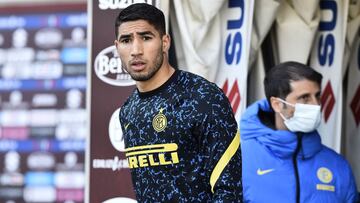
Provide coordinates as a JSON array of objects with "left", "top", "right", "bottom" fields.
[{"left": 115, "top": 20, "right": 167, "bottom": 81}]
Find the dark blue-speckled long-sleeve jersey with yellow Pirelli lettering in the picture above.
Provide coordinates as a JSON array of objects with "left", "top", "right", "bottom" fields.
[{"left": 120, "top": 70, "right": 242, "bottom": 202}]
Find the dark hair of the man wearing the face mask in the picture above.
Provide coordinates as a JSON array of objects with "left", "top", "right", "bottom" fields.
[{"left": 264, "top": 61, "right": 322, "bottom": 104}]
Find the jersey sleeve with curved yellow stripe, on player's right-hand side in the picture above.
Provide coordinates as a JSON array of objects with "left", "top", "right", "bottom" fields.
[{"left": 200, "top": 87, "right": 242, "bottom": 202}]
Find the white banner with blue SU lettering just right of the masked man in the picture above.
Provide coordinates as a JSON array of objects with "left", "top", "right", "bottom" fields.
[{"left": 310, "top": 0, "right": 349, "bottom": 153}]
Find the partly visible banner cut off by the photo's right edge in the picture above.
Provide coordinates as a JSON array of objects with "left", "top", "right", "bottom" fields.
[{"left": 345, "top": 34, "right": 360, "bottom": 190}]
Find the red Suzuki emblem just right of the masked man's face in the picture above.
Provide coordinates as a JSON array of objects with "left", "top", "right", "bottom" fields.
[{"left": 321, "top": 81, "right": 335, "bottom": 123}]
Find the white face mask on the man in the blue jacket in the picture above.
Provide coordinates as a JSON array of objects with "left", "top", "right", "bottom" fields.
[{"left": 278, "top": 99, "right": 321, "bottom": 133}]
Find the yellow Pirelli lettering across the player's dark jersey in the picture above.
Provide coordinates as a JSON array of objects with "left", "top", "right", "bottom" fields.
[{"left": 125, "top": 143, "right": 179, "bottom": 168}]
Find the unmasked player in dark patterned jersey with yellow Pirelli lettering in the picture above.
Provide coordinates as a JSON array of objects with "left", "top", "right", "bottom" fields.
[{"left": 115, "top": 4, "right": 242, "bottom": 202}]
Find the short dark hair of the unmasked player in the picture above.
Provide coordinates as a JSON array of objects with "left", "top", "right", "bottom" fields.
[{"left": 115, "top": 3, "right": 166, "bottom": 39}]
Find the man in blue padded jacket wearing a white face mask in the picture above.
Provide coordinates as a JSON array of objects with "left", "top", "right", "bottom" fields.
[{"left": 240, "top": 62, "right": 358, "bottom": 203}]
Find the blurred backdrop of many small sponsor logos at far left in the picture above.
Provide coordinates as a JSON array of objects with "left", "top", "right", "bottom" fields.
[{"left": 0, "top": 1, "right": 87, "bottom": 203}]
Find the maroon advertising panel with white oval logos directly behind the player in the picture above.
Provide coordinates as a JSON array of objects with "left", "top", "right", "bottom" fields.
[{"left": 87, "top": 0, "right": 156, "bottom": 203}]
